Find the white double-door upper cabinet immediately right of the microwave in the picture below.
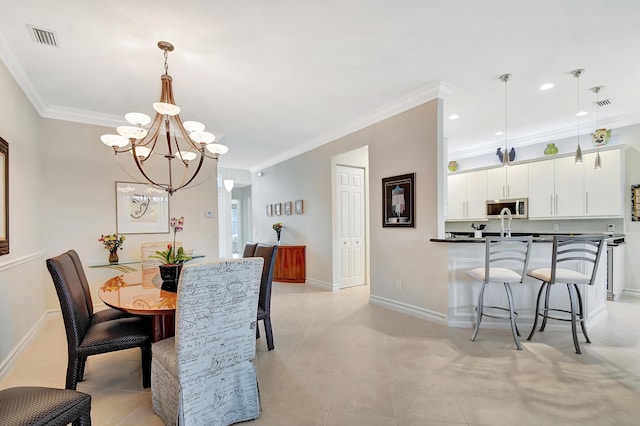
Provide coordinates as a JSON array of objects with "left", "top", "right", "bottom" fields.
[{"left": 528, "top": 157, "right": 584, "bottom": 219}]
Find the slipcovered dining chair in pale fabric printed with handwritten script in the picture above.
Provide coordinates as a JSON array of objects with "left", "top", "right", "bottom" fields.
[{"left": 151, "top": 257, "right": 263, "bottom": 425}]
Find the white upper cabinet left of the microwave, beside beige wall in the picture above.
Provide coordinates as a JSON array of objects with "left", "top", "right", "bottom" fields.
[{"left": 447, "top": 170, "right": 487, "bottom": 220}]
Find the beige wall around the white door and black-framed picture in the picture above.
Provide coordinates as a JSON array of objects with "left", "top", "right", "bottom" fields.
[{"left": 252, "top": 100, "right": 448, "bottom": 319}]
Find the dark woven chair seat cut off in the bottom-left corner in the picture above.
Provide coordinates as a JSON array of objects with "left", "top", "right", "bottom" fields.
[{"left": 0, "top": 386, "right": 91, "bottom": 426}]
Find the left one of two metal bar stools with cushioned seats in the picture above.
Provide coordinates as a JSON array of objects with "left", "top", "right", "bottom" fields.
[{"left": 467, "top": 236, "right": 533, "bottom": 351}]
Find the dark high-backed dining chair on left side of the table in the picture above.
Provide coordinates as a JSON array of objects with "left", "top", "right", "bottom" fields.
[{"left": 47, "top": 252, "right": 151, "bottom": 389}]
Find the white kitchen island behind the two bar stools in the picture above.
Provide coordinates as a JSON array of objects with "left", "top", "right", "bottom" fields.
[{"left": 430, "top": 233, "right": 616, "bottom": 330}]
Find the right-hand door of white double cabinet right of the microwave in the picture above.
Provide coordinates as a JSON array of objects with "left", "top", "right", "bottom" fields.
[{"left": 554, "top": 157, "right": 584, "bottom": 217}]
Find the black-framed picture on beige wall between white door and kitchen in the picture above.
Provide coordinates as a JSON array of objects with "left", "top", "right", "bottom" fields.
[{"left": 382, "top": 173, "right": 416, "bottom": 228}]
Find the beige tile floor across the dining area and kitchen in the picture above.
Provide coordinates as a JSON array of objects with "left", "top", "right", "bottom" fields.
[{"left": 0, "top": 283, "right": 640, "bottom": 426}]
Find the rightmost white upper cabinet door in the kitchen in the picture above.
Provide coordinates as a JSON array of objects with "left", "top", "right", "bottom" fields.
[{"left": 584, "top": 149, "right": 624, "bottom": 217}]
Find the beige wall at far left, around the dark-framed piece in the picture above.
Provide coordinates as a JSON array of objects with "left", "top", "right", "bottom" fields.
[{"left": 0, "top": 58, "right": 47, "bottom": 369}]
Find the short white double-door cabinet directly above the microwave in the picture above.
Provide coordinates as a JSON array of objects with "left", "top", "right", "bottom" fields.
[{"left": 487, "top": 164, "right": 529, "bottom": 200}]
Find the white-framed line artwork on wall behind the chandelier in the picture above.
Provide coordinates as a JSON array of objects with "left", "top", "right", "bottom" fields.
[{"left": 116, "top": 182, "right": 169, "bottom": 234}]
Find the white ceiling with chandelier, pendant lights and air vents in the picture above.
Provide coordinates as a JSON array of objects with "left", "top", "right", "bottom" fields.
[{"left": 0, "top": 0, "right": 640, "bottom": 170}]
